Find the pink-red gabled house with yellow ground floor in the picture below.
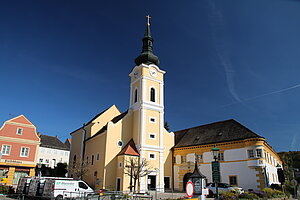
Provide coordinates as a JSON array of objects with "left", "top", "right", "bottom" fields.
[{"left": 0, "top": 115, "right": 40, "bottom": 186}]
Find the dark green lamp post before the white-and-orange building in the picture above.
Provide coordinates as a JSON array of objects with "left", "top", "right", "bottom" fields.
[{"left": 211, "top": 145, "right": 220, "bottom": 199}]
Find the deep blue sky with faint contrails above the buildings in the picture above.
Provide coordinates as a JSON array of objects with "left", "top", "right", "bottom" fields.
[{"left": 0, "top": 0, "right": 300, "bottom": 151}]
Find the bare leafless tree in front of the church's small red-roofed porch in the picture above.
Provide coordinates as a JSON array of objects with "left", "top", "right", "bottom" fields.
[{"left": 124, "top": 157, "right": 151, "bottom": 191}]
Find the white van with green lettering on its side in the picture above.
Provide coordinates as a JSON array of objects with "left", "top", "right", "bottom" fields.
[{"left": 43, "top": 179, "right": 94, "bottom": 200}]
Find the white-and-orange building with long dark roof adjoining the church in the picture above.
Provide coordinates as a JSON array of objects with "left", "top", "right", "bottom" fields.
[{"left": 174, "top": 120, "right": 282, "bottom": 191}]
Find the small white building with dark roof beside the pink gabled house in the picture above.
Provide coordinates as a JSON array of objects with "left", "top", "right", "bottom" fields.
[{"left": 37, "top": 135, "right": 70, "bottom": 169}]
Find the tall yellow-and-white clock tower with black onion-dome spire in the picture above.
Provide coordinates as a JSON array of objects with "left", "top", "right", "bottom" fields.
[{"left": 129, "top": 16, "right": 165, "bottom": 192}]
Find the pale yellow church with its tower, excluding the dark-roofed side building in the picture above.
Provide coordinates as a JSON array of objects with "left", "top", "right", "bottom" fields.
[{"left": 69, "top": 20, "right": 174, "bottom": 192}]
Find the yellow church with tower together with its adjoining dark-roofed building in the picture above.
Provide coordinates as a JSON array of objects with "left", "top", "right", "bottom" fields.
[{"left": 69, "top": 16, "right": 282, "bottom": 192}]
